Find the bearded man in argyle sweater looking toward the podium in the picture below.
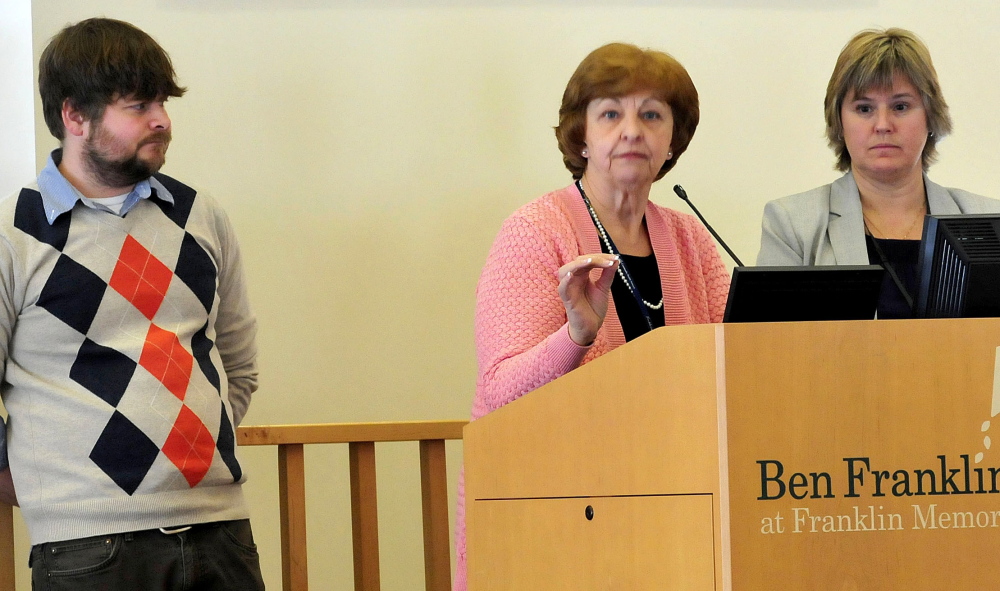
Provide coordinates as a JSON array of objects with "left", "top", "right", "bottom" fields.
[{"left": 0, "top": 18, "right": 264, "bottom": 591}]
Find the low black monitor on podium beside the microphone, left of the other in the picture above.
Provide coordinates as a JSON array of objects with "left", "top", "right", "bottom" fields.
[{"left": 723, "top": 265, "right": 885, "bottom": 322}]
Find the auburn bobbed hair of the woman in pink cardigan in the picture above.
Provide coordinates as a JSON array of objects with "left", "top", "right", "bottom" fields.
[{"left": 555, "top": 43, "right": 700, "bottom": 180}]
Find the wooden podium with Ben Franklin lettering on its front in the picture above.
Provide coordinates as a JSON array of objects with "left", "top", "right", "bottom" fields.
[{"left": 464, "top": 319, "right": 1000, "bottom": 591}]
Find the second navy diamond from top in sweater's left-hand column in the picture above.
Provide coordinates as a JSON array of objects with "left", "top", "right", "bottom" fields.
[{"left": 38, "top": 256, "right": 108, "bottom": 335}]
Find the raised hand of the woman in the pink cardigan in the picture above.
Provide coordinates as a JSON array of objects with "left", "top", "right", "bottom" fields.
[{"left": 557, "top": 253, "right": 618, "bottom": 346}]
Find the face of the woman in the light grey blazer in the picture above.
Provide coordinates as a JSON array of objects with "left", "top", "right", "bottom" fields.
[{"left": 840, "top": 74, "right": 927, "bottom": 182}]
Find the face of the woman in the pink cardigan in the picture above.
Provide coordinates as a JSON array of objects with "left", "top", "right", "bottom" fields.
[{"left": 585, "top": 91, "right": 674, "bottom": 189}]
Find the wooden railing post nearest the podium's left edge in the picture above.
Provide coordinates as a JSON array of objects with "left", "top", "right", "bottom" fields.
[{"left": 420, "top": 439, "right": 451, "bottom": 591}]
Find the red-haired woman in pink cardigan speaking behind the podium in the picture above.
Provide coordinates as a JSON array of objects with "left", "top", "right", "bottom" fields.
[{"left": 455, "top": 43, "right": 729, "bottom": 591}]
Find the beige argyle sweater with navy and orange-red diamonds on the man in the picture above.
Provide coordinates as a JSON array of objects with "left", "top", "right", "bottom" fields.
[{"left": 0, "top": 174, "right": 257, "bottom": 544}]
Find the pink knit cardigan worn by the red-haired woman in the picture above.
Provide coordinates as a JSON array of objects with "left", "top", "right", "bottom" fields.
[{"left": 454, "top": 185, "right": 729, "bottom": 591}]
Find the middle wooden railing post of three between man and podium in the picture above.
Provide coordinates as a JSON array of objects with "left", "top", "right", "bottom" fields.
[{"left": 348, "top": 441, "right": 381, "bottom": 591}]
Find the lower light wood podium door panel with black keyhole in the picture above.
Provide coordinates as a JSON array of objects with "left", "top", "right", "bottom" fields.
[{"left": 472, "top": 495, "right": 715, "bottom": 591}]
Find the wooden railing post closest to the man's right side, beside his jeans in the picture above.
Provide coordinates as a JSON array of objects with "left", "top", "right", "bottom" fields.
[{"left": 278, "top": 443, "right": 309, "bottom": 591}]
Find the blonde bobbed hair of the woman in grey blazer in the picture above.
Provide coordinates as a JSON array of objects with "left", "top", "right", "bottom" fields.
[{"left": 823, "top": 28, "right": 951, "bottom": 172}]
